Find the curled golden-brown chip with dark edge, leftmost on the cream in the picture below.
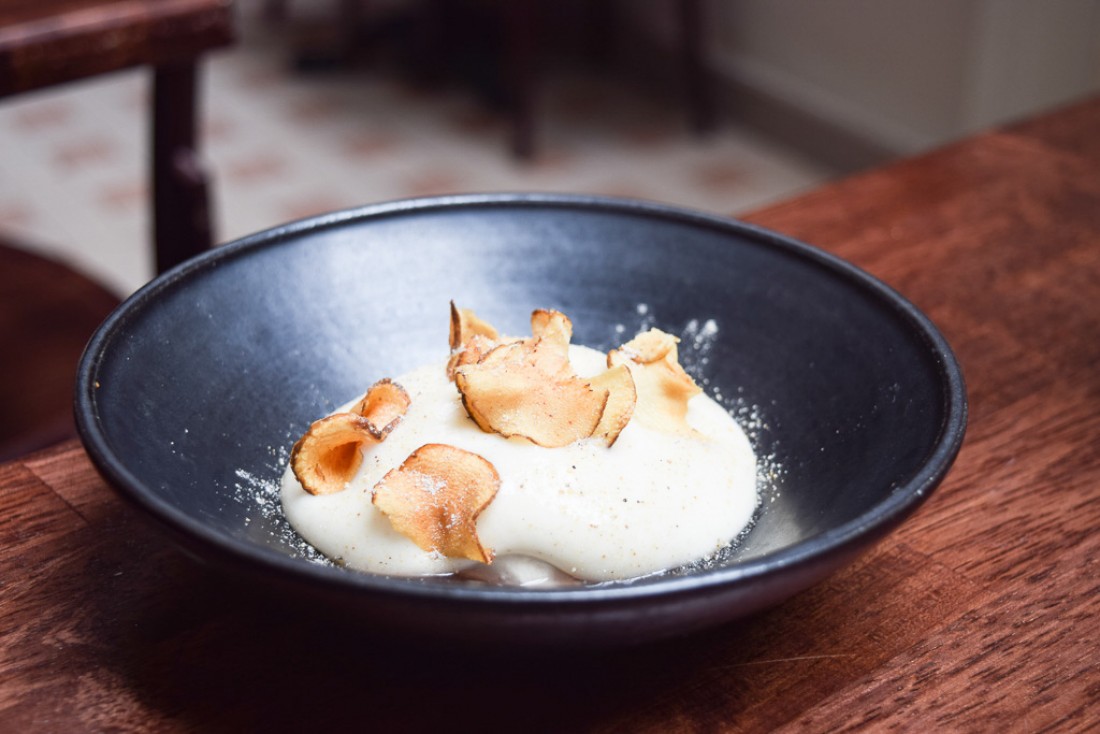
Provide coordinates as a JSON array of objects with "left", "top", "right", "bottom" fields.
[{"left": 290, "top": 413, "right": 374, "bottom": 494}]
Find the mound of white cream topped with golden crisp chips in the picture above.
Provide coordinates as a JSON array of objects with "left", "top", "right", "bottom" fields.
[{"left": 281, "top": 303, "right": 758, "bottom": 587}]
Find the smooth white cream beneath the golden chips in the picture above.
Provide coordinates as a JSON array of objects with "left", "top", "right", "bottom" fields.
[{"left": 282, "top": 346, "right": 757, "bottom": 583}]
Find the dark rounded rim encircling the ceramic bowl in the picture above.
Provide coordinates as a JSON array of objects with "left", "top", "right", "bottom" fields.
[{"left": 74, "top": 193, "right": 967, "bottom": 611}]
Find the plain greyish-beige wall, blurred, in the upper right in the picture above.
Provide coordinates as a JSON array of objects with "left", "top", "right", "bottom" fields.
[{"left": 620, "top": 0, "right": 1100, "bottom": 160}]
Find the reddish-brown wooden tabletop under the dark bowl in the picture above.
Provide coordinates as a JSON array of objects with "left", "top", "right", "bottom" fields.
[{"left": 0, "top": 99, "right": 1100, "bottom": 732}]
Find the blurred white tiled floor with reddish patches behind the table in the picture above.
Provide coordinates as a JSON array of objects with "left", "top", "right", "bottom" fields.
[{"left": 0, "top": 7, "right": 829, "bottom": 295}]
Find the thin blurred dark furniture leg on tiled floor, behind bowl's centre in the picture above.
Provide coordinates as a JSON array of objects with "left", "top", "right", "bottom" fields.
[{"left": 505, "top": 0, "right": 537, "bottom": 160}]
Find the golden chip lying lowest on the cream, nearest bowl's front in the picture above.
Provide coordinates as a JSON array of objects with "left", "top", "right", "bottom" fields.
[{"left": 371, "top": 443, "right": 501, "bottom": 563}]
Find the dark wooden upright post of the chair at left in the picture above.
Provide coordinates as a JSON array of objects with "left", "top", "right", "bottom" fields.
[{"left": 152, "top": 63, "right": 212, "bottom": 273}]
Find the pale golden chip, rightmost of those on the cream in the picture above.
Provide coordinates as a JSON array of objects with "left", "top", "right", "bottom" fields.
[{"left": 607, "top": 329, "right": 703, "bottom": 432}]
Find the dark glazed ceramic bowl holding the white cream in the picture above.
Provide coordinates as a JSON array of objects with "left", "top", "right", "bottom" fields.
[{"left": 76, "top": 195, "right": 966, "bottom": 644}]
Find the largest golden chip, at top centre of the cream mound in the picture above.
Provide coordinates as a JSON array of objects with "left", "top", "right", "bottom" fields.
[{"left": 454, "top": 333, "right": 608, "bottom": 448}]
